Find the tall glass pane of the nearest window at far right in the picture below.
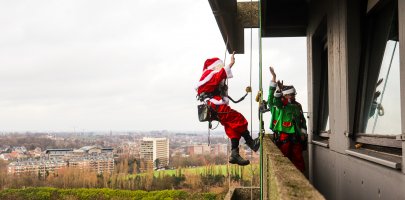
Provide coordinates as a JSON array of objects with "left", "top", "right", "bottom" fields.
[{"left": 359, "top": 1, "right": 401, "bottom": 136}]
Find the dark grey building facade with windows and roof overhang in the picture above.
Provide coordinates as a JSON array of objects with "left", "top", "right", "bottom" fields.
[{"left": 209, "top": 0, "right": 405, "bottom": 199}]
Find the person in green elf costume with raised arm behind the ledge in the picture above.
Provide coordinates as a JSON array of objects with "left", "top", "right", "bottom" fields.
[{"left": 267, "top": 67, "right": 307, "bottom": 172}]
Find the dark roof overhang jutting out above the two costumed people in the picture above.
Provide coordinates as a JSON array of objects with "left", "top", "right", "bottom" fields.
[{"left": 208, "top": 0, "right": 308, "bottom": 53}]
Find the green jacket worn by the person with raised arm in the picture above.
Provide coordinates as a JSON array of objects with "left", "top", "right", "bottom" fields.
[{"left": 267, "top": 82, "right": 307, "bottom": 135}]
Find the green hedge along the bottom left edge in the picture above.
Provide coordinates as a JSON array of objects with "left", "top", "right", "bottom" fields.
[{"left": 0, "top": 187, "right": 216, "bottom": 200}]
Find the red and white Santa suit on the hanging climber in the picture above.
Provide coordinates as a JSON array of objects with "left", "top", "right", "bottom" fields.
[{"left": 196, "top": 58, "right": 248, "bottom": 140}]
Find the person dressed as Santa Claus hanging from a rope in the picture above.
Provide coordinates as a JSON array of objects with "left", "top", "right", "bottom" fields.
[{"left": 196, "top": 52, "right": 260, "bottom": 165}]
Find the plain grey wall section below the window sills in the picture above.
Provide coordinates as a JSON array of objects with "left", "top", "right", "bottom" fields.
[{"left": 313, "top": 145, "right": 405, "bottom": 199}]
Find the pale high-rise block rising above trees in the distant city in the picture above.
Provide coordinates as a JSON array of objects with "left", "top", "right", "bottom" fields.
[{"left": 139, "top": 137, "right": 169, "bottom": 168}]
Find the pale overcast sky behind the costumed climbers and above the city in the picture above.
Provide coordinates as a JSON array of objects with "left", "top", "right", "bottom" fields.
[{"left": 0, "top": 0, "right": 307, "bottom": 132}]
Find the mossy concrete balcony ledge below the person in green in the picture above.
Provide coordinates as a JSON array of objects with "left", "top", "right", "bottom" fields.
[{"left": 263, "top": 135, "right": 325, "bottom": 199}]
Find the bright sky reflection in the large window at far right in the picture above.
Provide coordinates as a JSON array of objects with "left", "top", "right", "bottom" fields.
[{"left": 366, "top": 40, "right": 401, "bottom": 135}]
